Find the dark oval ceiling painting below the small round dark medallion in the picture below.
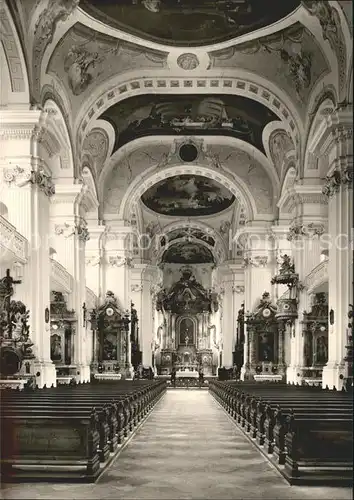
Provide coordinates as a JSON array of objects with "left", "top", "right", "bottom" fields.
[{"left": 141, "top": 175, "right": 235, "bottom": 217}]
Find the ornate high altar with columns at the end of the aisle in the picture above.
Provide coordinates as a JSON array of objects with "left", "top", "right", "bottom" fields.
[{"left": 156, "top": 267, "right": 218, "bottom": 376}]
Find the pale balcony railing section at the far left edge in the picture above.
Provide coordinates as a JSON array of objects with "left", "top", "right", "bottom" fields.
[{"left": 0, "top": 215, "right": 28, "bottom": 264}]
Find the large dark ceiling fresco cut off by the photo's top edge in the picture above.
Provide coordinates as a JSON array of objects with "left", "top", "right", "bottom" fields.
[{"left": 80, "top": 0, "right": 300, "bottom": 46}]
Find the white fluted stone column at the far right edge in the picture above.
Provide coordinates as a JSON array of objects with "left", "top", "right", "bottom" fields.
[{"left": 322, "top": 117, "right": 353, "bottom": 390}]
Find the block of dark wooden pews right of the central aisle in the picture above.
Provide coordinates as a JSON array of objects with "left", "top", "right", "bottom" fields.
[{"left": 209, "top": 381, "right": 353, "bottom": 486}]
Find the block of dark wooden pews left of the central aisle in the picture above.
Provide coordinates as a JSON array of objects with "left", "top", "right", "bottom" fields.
[{"left": 0, "top": 380, "right": 166, "bottom": 482}]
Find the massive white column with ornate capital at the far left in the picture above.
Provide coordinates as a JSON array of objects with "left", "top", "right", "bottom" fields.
[{"left": 0, "top": 110, "right": 56, "bottom": 388}]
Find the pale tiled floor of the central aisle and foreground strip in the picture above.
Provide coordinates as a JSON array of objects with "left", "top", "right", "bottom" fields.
[{"left": 1, "top": 389, "right": 352, "bottom": 500}]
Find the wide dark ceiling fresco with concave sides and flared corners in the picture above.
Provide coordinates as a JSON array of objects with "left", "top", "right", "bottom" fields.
[{"left": 100, "top": 94, "right": 279, "bottom": 153}]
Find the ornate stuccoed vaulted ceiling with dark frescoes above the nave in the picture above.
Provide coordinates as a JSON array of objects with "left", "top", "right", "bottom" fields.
[{"left": 2, "top": 0, "right": 351, "bottom": 230}]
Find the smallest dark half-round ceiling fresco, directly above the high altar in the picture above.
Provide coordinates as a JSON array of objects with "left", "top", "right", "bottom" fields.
[{"left": 162, "top": 241, "right": 214, "bottom": 264}]
